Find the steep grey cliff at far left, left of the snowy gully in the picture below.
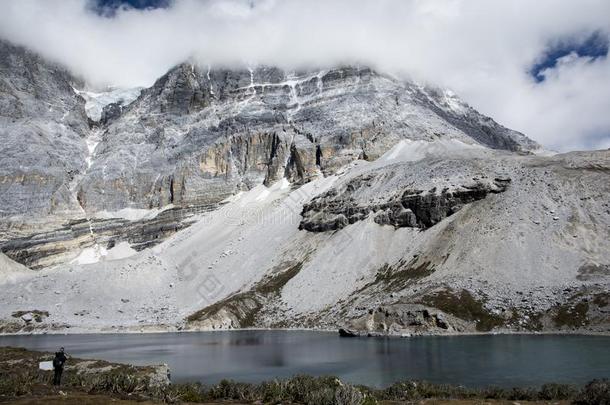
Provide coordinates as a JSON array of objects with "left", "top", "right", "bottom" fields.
[{"left": 0, "top": 41, "right": 89, "bottom": 218}]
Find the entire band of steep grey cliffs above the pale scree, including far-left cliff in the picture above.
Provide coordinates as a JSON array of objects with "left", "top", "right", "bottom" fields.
[{"left": 0, "top": 42, "right": 538, "bottom": 268}]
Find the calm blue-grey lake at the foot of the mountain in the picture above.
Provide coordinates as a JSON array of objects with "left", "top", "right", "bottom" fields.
[{"left": 0, "top": 331, "right": 610, "bottom": 387}]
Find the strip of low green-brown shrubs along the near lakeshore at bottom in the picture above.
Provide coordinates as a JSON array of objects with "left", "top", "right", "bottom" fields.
[{"left": 156, "top": 375, "right": 588, "bottom": 405}]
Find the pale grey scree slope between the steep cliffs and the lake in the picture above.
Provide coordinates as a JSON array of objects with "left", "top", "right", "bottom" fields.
[{"left": 0, "top": 147, "right": 610, "bottom": 335}]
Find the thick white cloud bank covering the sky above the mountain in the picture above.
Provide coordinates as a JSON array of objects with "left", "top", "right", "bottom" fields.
[{"left": 0, "top": 0, "right": 610, "bottom": 150}]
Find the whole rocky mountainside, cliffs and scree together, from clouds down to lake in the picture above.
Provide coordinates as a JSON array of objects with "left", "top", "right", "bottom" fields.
[{"left": 0, "top": 38, "right": 610, "bottom": 335}]
